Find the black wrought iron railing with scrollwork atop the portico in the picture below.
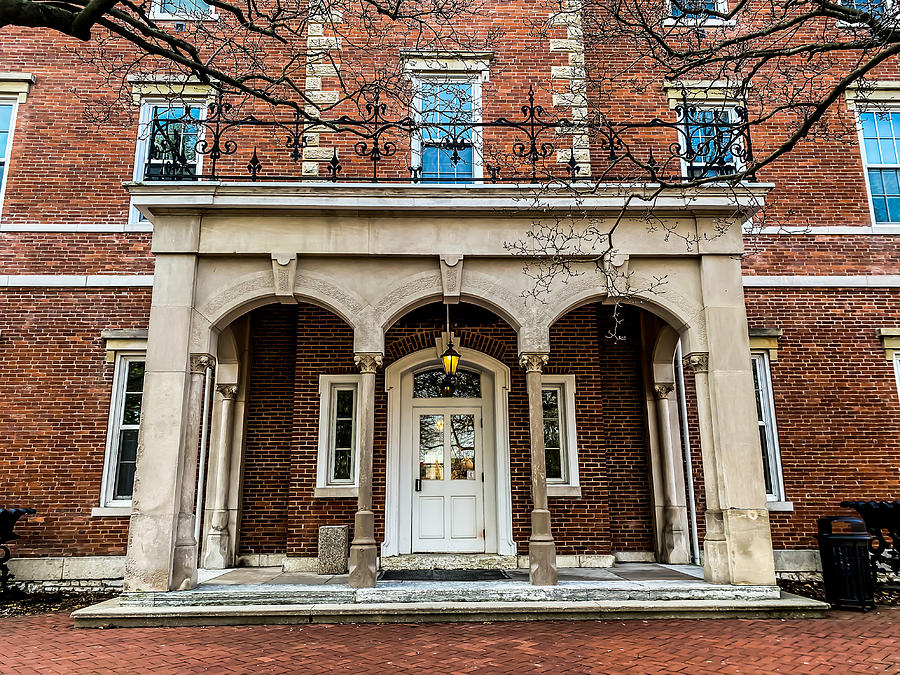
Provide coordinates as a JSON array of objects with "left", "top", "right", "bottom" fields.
[{"left": 144, "top": 88, "right": 756, "bottom": 183}]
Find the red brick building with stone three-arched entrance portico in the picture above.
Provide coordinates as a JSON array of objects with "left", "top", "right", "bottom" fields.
[{"left": 0, "top": 1, "right": 900, "bottom": 604}]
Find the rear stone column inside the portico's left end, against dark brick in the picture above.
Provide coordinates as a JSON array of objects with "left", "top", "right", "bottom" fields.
[{"left": 203, "top": 384, "right": 238, "bottom": 570}]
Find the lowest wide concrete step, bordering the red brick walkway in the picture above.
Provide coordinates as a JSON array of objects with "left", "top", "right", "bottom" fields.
[{"left": 72, "top": 593, "right": 828, "bottom": 628}]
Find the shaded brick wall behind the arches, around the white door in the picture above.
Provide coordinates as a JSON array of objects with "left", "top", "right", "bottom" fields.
[{"left": 240, "top": 303, "right": 652, "bottom": 556}]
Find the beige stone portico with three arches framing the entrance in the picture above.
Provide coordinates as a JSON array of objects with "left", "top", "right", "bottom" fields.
[{"left": 125, "top": 183, "right": 775, "bottom": 593}]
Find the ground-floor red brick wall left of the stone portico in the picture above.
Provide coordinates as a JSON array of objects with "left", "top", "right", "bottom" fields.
[{"left": 0, "top": 288, "right": 150, "bottom": 556}]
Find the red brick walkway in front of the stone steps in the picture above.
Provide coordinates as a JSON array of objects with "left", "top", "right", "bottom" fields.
[{"left": 0, "top": 609, "right": 900, "bottom": 675}]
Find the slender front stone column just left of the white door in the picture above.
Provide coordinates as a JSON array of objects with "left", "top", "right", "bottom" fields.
[{"left": 350, "top": 352, "right": 382, "bottom": 588}]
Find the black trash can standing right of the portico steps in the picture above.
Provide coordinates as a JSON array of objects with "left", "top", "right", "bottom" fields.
[{"left": 816, "top": 516, "right": 875, "bottom": 612}]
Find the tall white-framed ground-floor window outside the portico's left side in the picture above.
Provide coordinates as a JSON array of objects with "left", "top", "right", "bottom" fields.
[{"left": 101, "top": 353, "right": 144, "bottom": 506}]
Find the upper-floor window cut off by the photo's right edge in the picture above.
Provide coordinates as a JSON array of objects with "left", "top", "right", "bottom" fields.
[{"left": 859, "top": 112, "right": 900, "bottom": 223}]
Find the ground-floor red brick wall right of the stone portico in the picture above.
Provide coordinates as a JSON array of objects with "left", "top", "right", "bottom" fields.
[{"left": 747, "top": 289, "right": 900, "bottom": 548}]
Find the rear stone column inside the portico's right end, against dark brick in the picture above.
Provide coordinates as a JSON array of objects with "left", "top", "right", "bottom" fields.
[{"left": 653, "top": 383, "right": 690, "bottom": 564}]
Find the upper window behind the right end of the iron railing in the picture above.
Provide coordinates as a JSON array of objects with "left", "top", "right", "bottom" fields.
[{"left": 681, "top": 106, "right": 741, "bottom": 179}]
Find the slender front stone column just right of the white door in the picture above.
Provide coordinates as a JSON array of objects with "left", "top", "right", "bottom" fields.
[{"left": 520, "top": 354, "right": 557, "bottom": 586}]
